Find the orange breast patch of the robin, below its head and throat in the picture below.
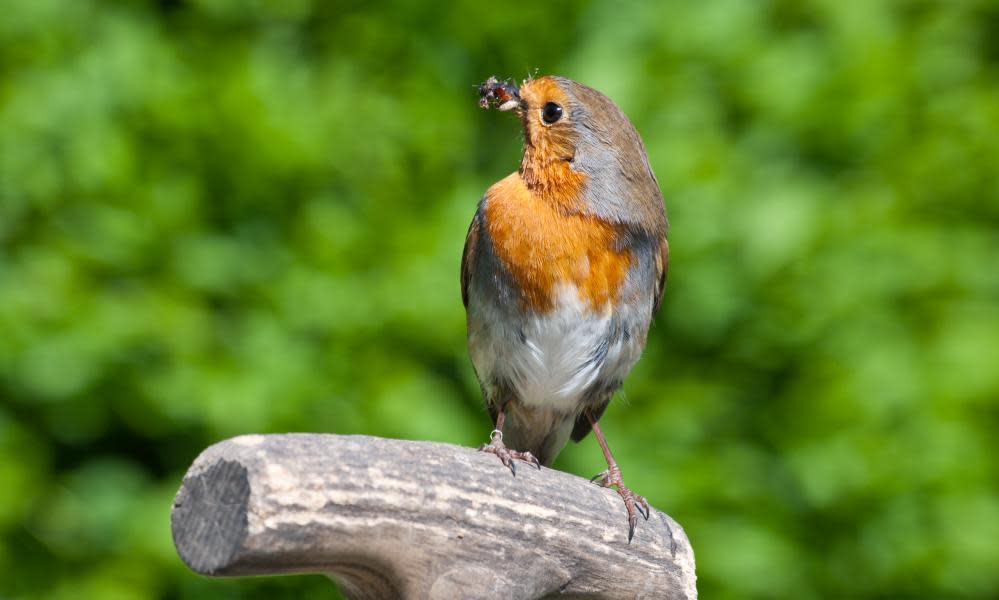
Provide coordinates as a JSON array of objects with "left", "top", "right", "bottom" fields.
[{"left": 485, "top": 173, "right": 631, "bottom": 312}]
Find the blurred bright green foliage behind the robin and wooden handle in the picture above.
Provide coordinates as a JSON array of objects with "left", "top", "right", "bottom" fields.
[{"left": 0, "top": 0, "right": 999, "bottom": 599}]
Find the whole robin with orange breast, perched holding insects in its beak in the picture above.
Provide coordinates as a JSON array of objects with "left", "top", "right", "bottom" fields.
[{"left": 461, "top": 76, "right": 669, "bottom": 543}]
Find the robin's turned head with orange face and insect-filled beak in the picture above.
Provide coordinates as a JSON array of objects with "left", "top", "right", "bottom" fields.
[{"left": 479, "top": 76, "right": 662, "bottom": 227}]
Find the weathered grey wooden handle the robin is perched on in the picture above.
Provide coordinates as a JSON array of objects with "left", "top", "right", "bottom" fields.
[{"left": 171, "top": 434, "right": 697, "bottom": 600}]
